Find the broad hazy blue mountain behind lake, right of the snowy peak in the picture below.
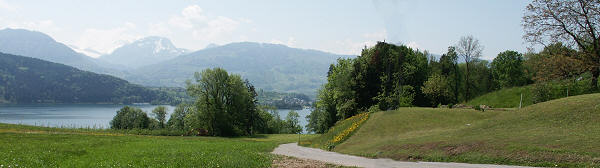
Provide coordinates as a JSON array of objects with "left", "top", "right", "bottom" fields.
[{"left": 131, "top": 42, "right": 350, "bottom": 96}]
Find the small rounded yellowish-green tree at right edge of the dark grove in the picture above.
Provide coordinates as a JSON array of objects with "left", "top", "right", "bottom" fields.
[{"left": 421, "top": 74, "right": 452, "bottom": 106}]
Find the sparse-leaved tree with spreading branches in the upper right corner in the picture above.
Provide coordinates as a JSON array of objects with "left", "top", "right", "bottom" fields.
[{"left": 523, "top": 0, "right": 600, "bottom": 90}]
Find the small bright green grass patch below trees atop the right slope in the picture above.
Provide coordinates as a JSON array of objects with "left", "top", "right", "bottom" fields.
[{"left": 467, "top": 85, "right": 533, "bottom": 108}]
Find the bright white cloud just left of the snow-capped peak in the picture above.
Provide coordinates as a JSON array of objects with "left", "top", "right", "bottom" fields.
[{"left": 74, "top": 22, "right": 141, "bottom": 53}]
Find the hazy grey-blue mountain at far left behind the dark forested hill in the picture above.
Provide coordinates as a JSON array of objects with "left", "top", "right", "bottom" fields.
[{"left": 0, "top": 28, "right": 123, "bottom": 76}]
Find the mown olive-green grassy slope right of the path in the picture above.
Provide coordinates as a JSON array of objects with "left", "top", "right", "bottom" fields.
[{"left": 312, "top": 94, "right": 600, "bottom": 167}]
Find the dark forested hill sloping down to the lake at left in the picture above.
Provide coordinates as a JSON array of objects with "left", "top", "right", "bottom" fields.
[{"left": 0, "top": 53, "right": 173, "bottom": 104}]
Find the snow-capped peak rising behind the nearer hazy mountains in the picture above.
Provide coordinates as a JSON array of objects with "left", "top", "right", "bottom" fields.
[{"left": 100, "top": 36, "right": 188, "bottom": 68}]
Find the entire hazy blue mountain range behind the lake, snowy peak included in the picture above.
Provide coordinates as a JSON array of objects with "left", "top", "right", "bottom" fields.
[{"left": 0, "top": 29, "right": 352, "bottom": 95}]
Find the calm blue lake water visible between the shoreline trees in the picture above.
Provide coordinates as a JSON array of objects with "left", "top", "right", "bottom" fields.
[{"left": 0, "top": 104, "right": 310, "bottom": 132}]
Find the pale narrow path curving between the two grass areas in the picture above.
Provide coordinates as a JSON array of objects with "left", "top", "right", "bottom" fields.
[{"left": 271, "top": 143, "right": 536, "bottom": 168}]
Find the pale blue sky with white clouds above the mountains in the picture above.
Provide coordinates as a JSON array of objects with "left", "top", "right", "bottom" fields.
[{"left": 0, "top": 0, "right": 530, "bottom": 60}]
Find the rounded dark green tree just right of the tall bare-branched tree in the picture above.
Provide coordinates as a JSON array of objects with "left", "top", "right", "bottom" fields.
[{"left": 491, "top": 51, "right": 527, "bottom": 87}]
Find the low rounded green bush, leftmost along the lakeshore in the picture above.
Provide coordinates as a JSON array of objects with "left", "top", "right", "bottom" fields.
[{"left": 110, "top": 106, "right": 151, "bottom": 129}]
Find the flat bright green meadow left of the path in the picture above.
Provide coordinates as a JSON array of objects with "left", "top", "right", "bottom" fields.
[{"left": 0, "top": 124, "right": 314, "bottom": 167}]
